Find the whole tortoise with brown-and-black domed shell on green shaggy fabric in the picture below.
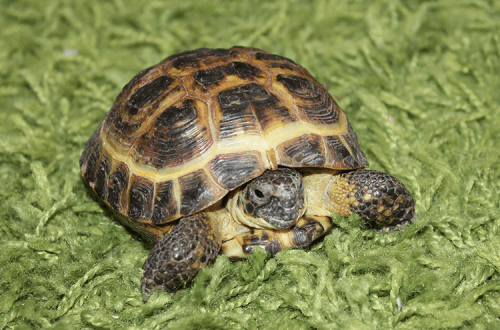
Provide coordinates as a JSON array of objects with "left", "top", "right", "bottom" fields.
[{"left": 80, "top": 46, "right": 415, "bottom": 299}]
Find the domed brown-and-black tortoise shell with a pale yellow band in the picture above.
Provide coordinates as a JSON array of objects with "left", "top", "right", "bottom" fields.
[{"left": 80, "top": 47, "right": 368, "bottom": 224}]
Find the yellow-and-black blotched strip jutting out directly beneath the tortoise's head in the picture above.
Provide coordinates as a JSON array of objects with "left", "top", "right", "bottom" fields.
[{"left": 221, "top": 216, "right": 333, "bottom": 258}]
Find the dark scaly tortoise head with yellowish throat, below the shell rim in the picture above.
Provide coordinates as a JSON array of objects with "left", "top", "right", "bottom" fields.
[{"left": 237, "top": 168, "right": 306, "bottom": 229}]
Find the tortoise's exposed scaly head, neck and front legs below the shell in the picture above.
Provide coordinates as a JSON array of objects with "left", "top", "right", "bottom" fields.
[{"left": 142, "top": 169, "right": 415, "bottom": 299}]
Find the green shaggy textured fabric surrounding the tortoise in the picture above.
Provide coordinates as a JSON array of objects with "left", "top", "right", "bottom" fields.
[{"left": 0, "top": 0, "right": 500, "bottom": 329}]
